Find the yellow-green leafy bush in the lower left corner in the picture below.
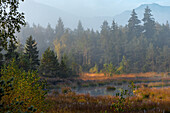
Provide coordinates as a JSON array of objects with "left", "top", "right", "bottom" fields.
[{"left": 1, "top": 61, "right": 46, "bottom": 112}]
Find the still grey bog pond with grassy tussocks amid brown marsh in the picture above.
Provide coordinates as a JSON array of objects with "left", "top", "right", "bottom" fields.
[{"left": 50, "top": 77, "right": 170, "bottom": 96}]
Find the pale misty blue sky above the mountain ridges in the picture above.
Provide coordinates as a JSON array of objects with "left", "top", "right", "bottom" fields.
[{"left": 34, "top": 0, "right": 170, "bottom": 16}]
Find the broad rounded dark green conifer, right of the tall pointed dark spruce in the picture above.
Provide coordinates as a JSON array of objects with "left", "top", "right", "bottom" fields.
[{"left": 39, "top": 48, "right": 60, "bottom": 77}]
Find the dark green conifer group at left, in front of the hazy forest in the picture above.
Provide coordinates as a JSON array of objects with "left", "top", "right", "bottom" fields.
[{"left": 0, "top": 36, "right": 76, "bottom": 78}]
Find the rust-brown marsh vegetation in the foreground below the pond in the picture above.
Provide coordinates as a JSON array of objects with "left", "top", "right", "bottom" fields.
[{"left": 48, "top": 88, "right": 170, "bottom": 113}]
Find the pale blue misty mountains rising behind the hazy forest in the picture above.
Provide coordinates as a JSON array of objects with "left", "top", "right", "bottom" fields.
[{"left": 20, "top": 0, "right": 170, "bottom": 30}]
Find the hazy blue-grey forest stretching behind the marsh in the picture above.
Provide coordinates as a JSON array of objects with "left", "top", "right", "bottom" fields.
[{"left": 15, "top": 7, "right": 170, "bottom": 73}]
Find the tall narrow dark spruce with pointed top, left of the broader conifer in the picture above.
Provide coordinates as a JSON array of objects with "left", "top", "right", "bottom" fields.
[{"left": 24, "top": 36, "right": 39, "bottom": 70}]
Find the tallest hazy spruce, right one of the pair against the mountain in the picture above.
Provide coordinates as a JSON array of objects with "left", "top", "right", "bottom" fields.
[{"left": 142, "top": 6, "right": 155, "bottom": 38}]
